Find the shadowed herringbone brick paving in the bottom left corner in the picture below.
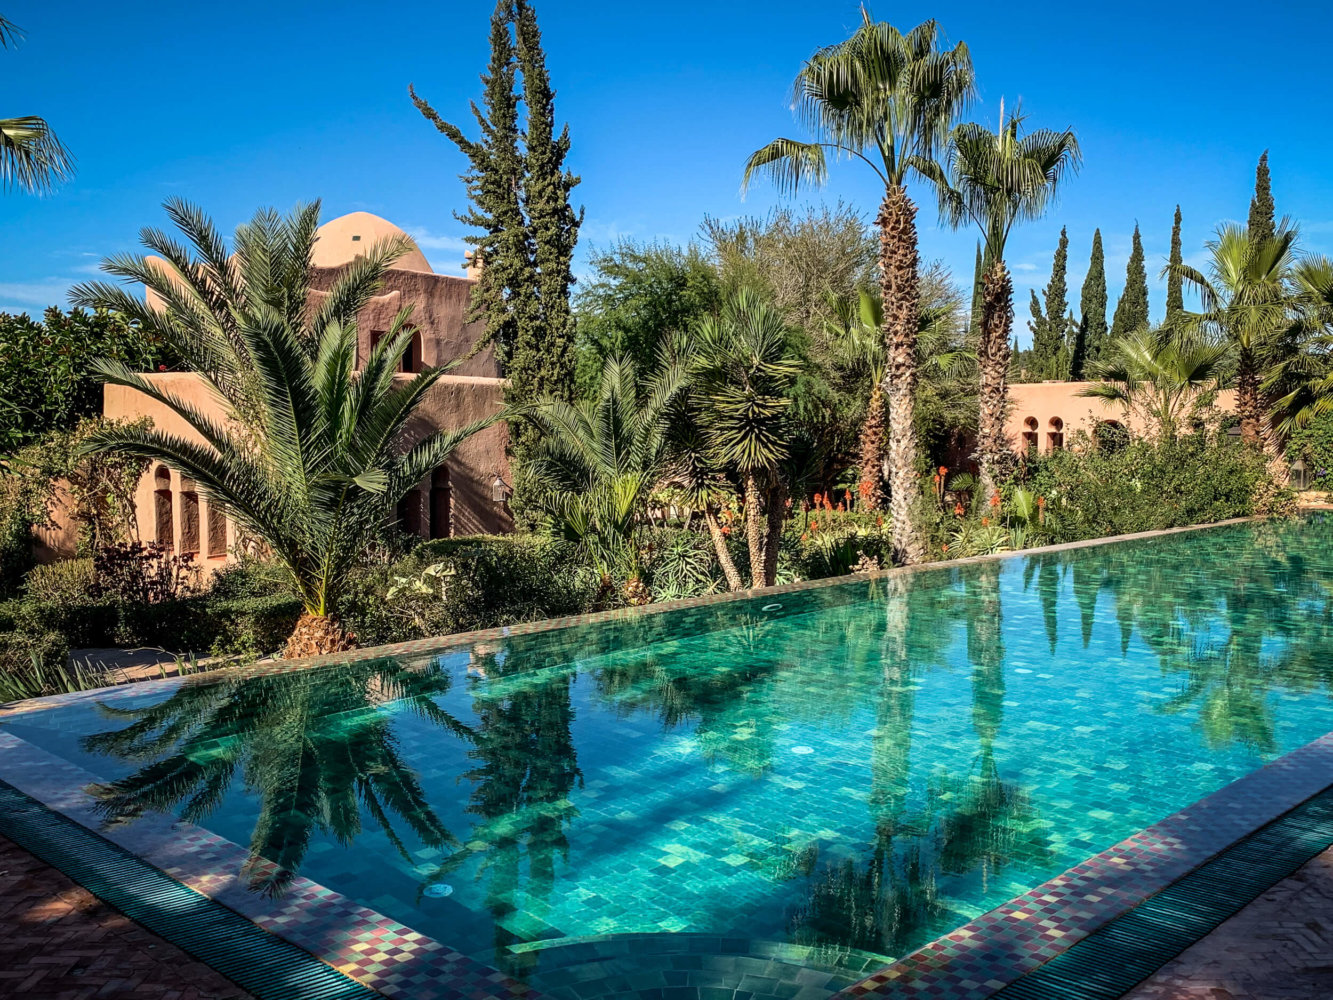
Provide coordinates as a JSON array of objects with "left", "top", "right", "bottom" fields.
[{"left": 0, "top": 837, "right": 253, "bottom": 1000}]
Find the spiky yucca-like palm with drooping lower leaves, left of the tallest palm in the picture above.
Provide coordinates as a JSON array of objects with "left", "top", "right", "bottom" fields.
[{"left": 689, "top": 289, "right": 800, "bottom": 587}]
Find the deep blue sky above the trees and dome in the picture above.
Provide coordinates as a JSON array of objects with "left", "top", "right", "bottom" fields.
[{"left": 0, "top": 0, "right": 1333, "bottom": 339}]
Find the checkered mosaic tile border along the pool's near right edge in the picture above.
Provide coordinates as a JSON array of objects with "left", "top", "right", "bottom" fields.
[{"left": 834, "top": 733, "right": 1333, "bottom": 1000}]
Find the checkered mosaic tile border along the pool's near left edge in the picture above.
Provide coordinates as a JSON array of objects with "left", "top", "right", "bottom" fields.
[{"left": 0, "top": 732, "right": 557, "bottom": 1000}]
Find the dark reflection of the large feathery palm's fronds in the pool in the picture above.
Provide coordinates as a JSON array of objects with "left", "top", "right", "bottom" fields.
[{"left": 83, "top": 659, "right": 473, "bottom": 896}]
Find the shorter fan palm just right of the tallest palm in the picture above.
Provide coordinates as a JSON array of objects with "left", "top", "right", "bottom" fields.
[{"left": 925, "top": 103, "right": 1081, "bottom": 495}]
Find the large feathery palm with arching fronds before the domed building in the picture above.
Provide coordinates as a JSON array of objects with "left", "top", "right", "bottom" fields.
[{"left": 72, "top": 201, "right": 499, "bottom": 656}]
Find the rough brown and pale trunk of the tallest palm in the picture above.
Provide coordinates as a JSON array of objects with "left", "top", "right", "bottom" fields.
[{"left": 874, "top": 184, "right": 925, "bottom": 565}]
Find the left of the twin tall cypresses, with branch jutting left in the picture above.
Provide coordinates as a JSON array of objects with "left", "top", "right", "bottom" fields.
[{"left": 408, "top": 0, "right": 532, "bottom": 371}]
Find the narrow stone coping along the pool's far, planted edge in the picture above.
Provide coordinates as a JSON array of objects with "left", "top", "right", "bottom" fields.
[{"left": 0, "top": 517, "right": 1264, "bottom": 719}]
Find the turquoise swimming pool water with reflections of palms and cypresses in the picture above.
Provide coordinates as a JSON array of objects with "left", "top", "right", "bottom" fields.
[{"left": 4, "top": 515, "right": 1333, "bottom": 980}]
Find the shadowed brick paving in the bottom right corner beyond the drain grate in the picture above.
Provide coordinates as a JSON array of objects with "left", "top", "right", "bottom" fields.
[{"left": 1124, "top": 848, "right": 1333, "bottom": 1000}]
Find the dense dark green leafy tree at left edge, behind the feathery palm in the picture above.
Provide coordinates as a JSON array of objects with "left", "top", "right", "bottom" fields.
[{"left": 0, "top": 307, "right": 168, "bottom": 453}]
